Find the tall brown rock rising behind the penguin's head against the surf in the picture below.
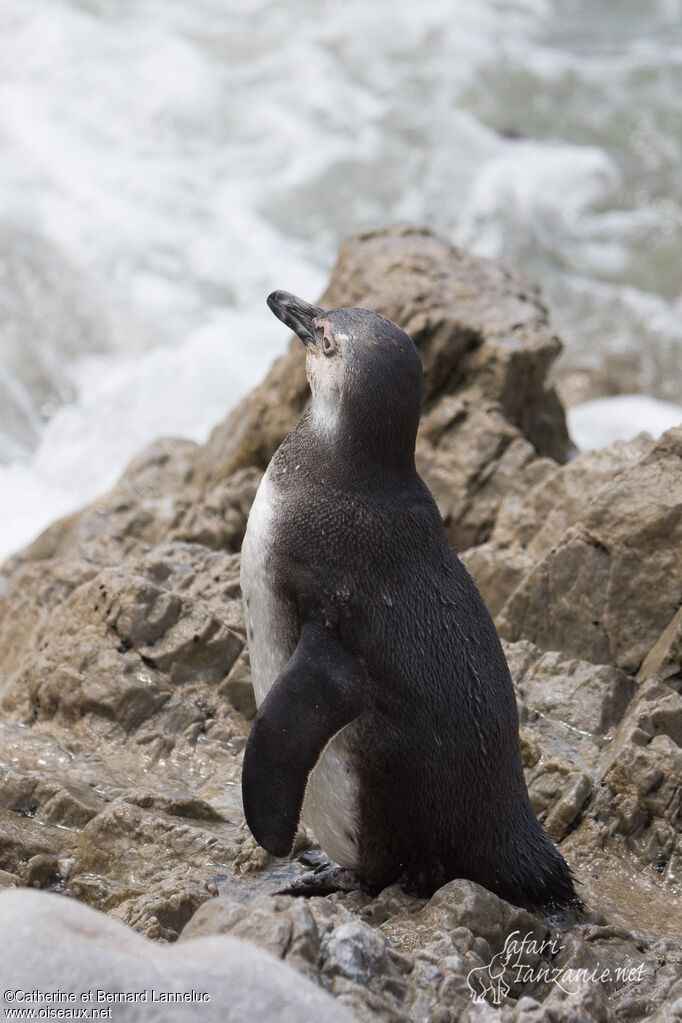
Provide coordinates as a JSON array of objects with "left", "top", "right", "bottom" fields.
[{"left": 196, "top": 227, "right": 569, "bottom": 488}]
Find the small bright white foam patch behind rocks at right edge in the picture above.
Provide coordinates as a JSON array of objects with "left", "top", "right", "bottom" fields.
[{"left": 566, "top": 394, "right": 682, "bottom": 451}]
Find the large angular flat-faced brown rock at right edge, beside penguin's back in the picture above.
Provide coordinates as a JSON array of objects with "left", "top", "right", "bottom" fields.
[{"left": 498, "top": 428, "right": 682, "bottom": 672}]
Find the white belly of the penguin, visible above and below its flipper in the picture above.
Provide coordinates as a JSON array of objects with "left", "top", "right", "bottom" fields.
[{"left": 241, "top": 473, "right": 359, "bottom": 870}]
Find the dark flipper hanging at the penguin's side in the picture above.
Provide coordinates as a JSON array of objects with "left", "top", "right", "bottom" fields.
[{"left": 241, "top": 622, "right": 366, "bottom": 856}]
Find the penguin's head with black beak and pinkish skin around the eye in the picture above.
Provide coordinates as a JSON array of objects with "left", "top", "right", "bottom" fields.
[{"left": 268, "top": 292, "right": 422, "bottom": 474}]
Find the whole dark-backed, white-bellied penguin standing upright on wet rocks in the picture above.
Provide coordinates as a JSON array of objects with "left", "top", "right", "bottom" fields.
[{"left": 241, "top": 292, "right": 580, "bottom": 911}]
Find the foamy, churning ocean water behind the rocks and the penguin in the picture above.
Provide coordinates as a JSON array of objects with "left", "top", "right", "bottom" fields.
[{"left": 0, "top": 0, "right": 682, "bottom": 559}]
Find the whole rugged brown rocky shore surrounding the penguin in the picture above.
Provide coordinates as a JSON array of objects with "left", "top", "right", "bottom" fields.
[{"left": 0, "top": 228, "right": 682, "bottom": 1023}]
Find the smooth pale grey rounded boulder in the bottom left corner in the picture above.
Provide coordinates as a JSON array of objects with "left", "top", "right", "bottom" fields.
[{"left": 0, "top": 890, "right": 353, "bottom": 1023}]
